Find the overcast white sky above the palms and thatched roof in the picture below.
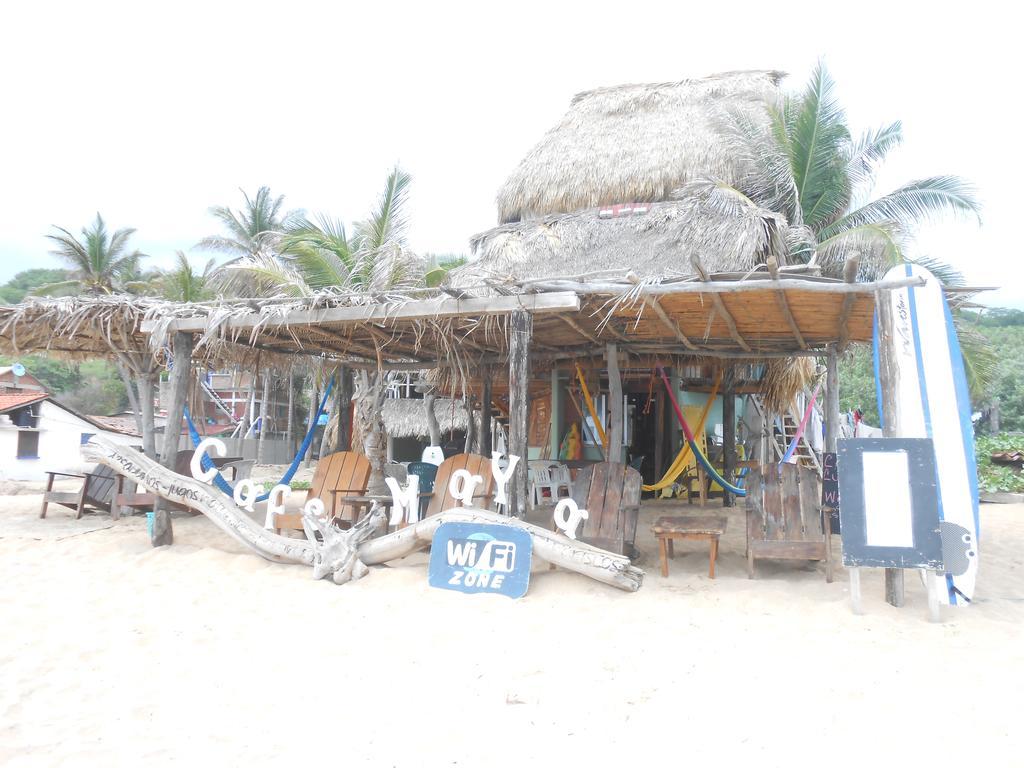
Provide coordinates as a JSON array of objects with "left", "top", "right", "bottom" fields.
[{"left": 0, "top": 0, "right": 1024, "bottom": 306}]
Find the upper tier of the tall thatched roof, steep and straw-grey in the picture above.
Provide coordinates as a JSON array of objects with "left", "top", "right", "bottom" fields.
[{"left": 498, "top": 71, "right": 783, "bottom": 223}]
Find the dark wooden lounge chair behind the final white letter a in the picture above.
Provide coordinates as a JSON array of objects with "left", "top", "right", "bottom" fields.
[{"left": 572, "top": 462, "right": 643, "bottom": 559}]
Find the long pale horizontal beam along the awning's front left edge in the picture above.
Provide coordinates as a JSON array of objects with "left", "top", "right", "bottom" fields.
[{"left": 142, "top": 292, "right": 580, "bottom": 333}]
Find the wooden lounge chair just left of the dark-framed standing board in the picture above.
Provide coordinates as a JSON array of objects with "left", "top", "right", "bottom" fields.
[{"left": 744, "top": 464, "right": 833, "bottom": 583}]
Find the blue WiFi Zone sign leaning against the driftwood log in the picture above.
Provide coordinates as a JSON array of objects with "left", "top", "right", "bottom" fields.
[{"left": 429, "top": 522, "right": 534, "bottom": 597}]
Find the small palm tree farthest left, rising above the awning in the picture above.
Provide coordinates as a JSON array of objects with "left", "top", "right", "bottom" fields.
[{"left": 34, "top": 213, "right": 145, "bottom": 295}]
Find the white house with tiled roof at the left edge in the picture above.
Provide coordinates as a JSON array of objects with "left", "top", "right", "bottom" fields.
[{"left": 0, "top": 390, "right": 142, "bottom": 482}]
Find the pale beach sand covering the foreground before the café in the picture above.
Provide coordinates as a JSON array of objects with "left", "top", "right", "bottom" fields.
[{"left": 0, "top": 495, "right": 1024, "bottom": 766}]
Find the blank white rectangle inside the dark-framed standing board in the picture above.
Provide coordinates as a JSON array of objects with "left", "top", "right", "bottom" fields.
[{"left": 863, "top": 451, "right": 913, "bottom": 547}]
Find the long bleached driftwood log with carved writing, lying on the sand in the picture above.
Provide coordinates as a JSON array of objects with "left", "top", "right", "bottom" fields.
[{"left": 83, "top": 435, "right": 644, "bottom": 592}]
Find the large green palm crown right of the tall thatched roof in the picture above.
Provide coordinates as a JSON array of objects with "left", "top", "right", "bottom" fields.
[{"left": 712, "top": 61, "right": 980, "bottom": 276}]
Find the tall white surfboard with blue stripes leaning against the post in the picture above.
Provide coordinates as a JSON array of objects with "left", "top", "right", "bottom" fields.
[{"left": 874, "top": 264, "right": 979, "bottom": 605}]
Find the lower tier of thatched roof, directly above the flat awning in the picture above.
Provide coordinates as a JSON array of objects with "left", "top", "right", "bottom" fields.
[{"left": 446, "top": 183, "right": 800, "bottom": 289}]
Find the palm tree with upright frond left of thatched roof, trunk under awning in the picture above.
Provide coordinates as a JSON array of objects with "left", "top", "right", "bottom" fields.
[{"left": 221, "top": 168, "right": 424, "bottom": 493}]
